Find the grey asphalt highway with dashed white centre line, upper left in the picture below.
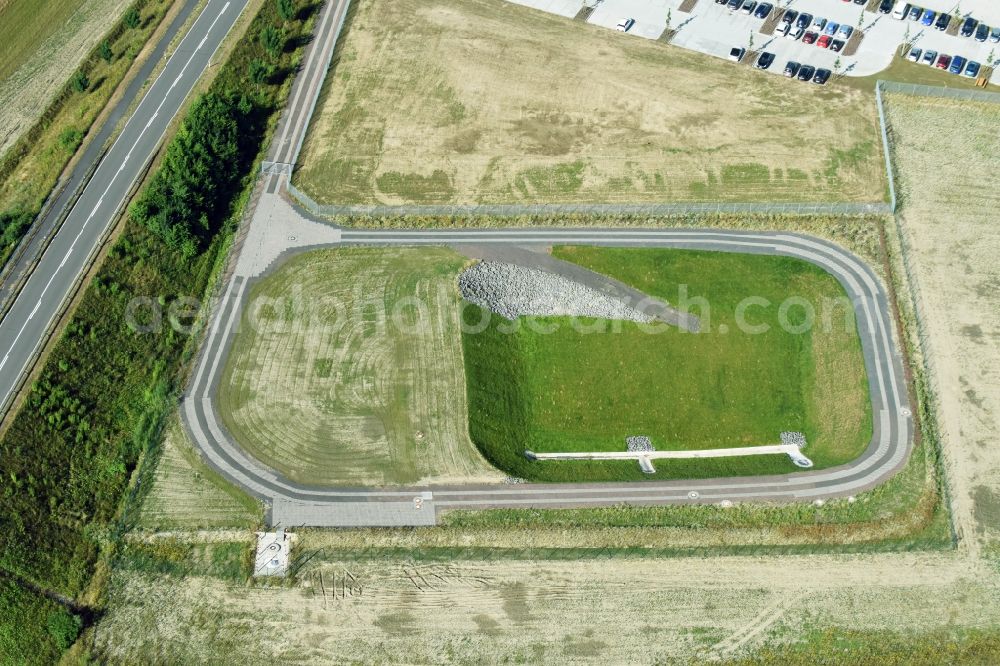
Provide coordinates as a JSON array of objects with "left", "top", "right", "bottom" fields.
[{"left": 0, "top": 0, "right": 247, "bottom": 413}]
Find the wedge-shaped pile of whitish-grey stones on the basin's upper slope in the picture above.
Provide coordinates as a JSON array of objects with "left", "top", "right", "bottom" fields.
[{"left": 458, "top": 261, "right": 653, "bottom": 323}]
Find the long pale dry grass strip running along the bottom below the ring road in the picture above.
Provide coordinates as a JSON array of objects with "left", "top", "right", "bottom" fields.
[{"left": 94, "top": 554, "right": 1000, "bottom": 664}]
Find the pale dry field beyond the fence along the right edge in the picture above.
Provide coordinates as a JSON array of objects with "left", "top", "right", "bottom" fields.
[{"left": 886, "top": 95, "right": 1000, "bottom": 541}]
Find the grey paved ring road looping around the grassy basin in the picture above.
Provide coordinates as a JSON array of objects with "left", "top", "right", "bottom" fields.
[{"left": 182, "top": 218, "right": 914, "bottom": 525}]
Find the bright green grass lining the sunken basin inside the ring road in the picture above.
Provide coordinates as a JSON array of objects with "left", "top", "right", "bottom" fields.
[{"left": 464, "top": 247, "right": 872, "bottom": 481}]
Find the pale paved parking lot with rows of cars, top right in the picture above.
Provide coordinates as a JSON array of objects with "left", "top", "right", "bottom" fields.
[{"left": 512, "top": 0, "right": 1000, "bottom": 85}]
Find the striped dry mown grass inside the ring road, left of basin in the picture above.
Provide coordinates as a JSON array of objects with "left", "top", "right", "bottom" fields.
[{"left": 219, "top": 248, "right": 501, "bottom": 485}]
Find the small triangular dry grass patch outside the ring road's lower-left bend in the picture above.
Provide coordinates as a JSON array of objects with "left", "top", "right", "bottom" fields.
[{"left": 140, "top": 419, "right": 263, "bottom": 530}]
